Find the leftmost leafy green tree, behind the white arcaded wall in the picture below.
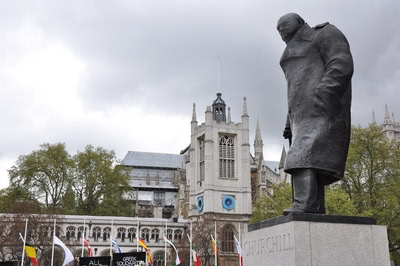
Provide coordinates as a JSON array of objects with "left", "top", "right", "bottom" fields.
[{"left": 9, "top": 143, "right": 73, "bottom": 212}]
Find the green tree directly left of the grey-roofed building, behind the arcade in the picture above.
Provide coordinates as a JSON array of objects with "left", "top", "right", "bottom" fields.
[{"left": 72, "top": 145, "right": 132, "bottom": 216}]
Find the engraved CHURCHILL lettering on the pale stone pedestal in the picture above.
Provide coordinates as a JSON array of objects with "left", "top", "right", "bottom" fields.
[{"left": 243, "top": 234, "right": 294, "bottom": 256}]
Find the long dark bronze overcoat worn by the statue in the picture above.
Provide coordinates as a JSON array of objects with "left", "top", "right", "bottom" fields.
[{"left": 280, "top": 23, "right": 353, "bottom": 184}]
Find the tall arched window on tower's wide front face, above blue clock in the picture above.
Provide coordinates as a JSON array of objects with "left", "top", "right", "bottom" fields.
[{"left": 219, "top": 136, "right": 235, "bottom": 178}]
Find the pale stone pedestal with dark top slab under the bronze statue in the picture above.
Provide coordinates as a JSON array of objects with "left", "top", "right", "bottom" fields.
[{"left": 242, "top": 213, "right": 390, "bottom": 266}]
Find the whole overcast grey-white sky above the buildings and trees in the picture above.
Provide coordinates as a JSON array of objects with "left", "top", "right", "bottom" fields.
[{"left": 0, "top": 0, "right": 400, "bottom": 188}]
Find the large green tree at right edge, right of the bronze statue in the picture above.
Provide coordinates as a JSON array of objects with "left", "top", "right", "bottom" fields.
[{"left": 342, "top": 124, "right": 400, "bottom": 263}]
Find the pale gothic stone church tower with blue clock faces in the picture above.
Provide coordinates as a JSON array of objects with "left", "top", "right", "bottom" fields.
[{"left": 186, "top": 93, "right": 252, "bottom": 265}]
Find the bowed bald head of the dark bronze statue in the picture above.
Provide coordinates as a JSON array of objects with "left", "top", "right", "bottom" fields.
[{"left": 276, "top": 13, "right": 304, "bottom": 43}]
